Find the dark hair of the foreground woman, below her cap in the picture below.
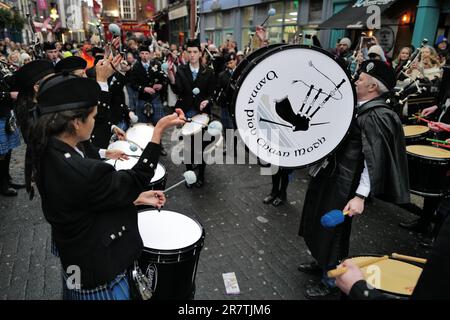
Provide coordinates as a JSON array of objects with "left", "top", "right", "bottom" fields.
[{"left": 30, "top": 107, "right": 95, "bottom": 171}]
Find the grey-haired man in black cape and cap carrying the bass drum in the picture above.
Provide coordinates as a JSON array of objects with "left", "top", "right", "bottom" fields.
[{"left": 299, "top": 60, "right": 409, "bottom": 299}]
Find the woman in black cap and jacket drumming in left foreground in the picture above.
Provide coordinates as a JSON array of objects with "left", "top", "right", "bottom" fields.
[{"left": 31, "top": 75, "right": 185, "bottom": 299}]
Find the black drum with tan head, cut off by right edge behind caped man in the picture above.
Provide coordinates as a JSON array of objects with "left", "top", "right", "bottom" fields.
[{"left": 406, "top": 145, "right": 450, "bottom": 197}]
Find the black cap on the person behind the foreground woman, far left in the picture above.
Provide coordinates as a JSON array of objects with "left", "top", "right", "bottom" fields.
[{"left": 15, "top": 59, "right": 55, "bottom": 89}]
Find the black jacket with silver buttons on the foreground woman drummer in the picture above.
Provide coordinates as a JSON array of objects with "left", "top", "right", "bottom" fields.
[{"left": 37, "top": 138, "right": 160, "bottom": 289}]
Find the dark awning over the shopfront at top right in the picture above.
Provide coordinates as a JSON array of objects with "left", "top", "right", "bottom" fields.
[{"left": 319, "top": 0, "right": 399, "bottom": 29}]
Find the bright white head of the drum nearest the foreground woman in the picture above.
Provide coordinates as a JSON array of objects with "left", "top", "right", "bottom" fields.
[{"left": 138, "top": 210, "right": 202, "bottom": 250}]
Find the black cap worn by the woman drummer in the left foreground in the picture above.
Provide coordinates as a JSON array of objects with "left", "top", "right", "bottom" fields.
[{"left": 37, "top": 74, "right": 101, "bottom": 115}]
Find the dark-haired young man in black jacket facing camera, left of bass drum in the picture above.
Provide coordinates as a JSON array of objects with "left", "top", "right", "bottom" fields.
[{"left": 168, "top": 39, "right": 216, "bottom": 188}]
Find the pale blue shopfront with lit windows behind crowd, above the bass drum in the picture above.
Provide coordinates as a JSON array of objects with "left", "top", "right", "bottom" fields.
[{"left": 200, "top": 0, "right": 331, "bottom": 49}]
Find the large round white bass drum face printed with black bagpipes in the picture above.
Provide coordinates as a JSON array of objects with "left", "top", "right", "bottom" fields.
[{"left": 232, "top": 45, "right": 356, "bottom": 168}]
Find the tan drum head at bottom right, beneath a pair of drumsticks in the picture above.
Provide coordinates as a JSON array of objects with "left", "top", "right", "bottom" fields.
[{"left": 350, "top": 255, "right": 422, "bottom": 299}]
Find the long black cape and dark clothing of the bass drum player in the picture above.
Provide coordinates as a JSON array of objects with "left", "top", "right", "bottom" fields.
[{"left": 299, "top": 99, "right": 409, "bottom": 269}]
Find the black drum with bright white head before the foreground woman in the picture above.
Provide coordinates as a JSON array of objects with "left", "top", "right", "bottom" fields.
[{"left": 138, "top": 210, "right": 205, "bottom": 300}]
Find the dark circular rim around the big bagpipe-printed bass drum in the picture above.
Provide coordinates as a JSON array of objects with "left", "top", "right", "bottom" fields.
[{"left": 230, "top": 44, "right": 357, "bottom": 169}]
